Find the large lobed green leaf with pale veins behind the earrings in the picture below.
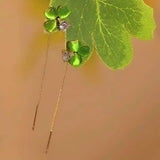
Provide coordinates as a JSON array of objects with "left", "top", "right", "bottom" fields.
[{"left": 50, "top": 0, "right": 155, "bottom": 70}]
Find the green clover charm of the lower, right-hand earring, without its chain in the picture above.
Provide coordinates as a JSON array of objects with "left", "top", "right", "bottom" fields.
[{"left": 62, "top": 40, "right": 90, "bottom": 67}]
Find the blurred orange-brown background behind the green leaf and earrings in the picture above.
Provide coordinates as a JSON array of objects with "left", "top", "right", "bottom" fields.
[{"left": 0, "top": 0, "right": 160, "bottom": 160}]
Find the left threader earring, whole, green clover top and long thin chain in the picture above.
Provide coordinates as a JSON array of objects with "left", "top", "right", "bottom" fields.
[{"left": 32, "top": 6, "right": 71, "bottom": 130}]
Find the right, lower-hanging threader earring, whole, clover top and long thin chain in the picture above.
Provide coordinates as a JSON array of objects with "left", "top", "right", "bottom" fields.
[{"left": 46, "top": 40, "right": 90, "bottom": 153}]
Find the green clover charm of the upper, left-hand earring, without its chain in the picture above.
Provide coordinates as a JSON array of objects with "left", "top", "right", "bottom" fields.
[{"left": 44, "top": 6, "right": 71, "bottom": 32}]
